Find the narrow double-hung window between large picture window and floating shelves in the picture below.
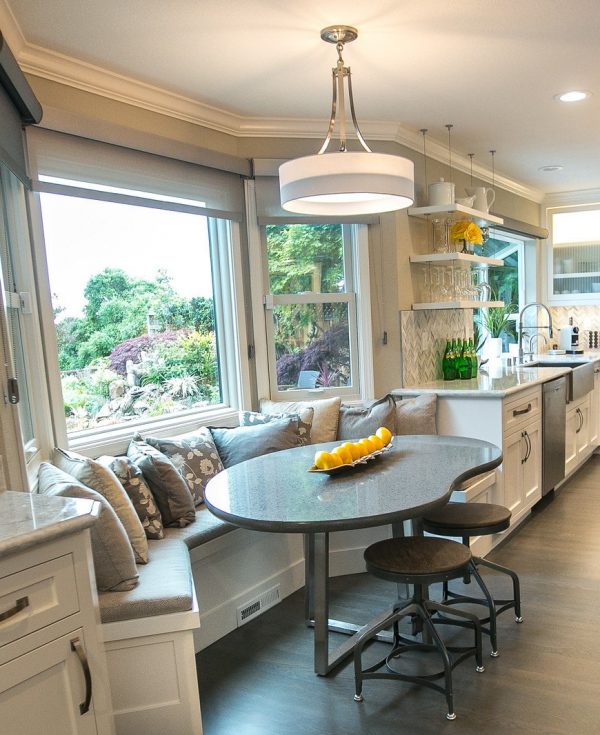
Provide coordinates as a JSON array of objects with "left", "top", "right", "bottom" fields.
[{"left": 262, "top": 224, "right": 360, "bottom": 397}]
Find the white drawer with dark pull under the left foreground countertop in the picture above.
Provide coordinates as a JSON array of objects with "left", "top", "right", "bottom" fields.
[{"left": 0, "top": 554, "right": 79, "bottom": 647}]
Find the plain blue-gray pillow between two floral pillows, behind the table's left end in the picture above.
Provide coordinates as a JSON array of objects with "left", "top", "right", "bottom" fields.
[{"left": 210, "top": 418, "right": 301, "bottom": 467}]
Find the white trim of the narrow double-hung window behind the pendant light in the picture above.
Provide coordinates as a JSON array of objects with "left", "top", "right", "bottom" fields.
[{"left": 245, "top": 181, "right": 375, "bottom": 401}]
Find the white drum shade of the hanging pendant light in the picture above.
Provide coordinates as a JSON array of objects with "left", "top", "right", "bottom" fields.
[{"left": 279, "top": 151, "right": 414, "bottom": 216}]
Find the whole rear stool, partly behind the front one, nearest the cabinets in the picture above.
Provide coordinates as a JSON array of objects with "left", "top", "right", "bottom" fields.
[{"left": 421, "top": 503, "right": 523, "bottom": 656}]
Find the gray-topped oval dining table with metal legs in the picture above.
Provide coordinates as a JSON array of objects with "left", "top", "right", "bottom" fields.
[{"left": 205, "top": 435, "right": 502, "bottom": 675}]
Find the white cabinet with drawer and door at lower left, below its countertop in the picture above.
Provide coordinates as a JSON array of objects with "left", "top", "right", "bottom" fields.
[{"left": 0, "top": 516, "right": 114, "bottom": 735}]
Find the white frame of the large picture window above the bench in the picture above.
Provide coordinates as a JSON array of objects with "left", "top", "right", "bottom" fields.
[{"left": 31, "top": 192, "right": 251, "bottom": 457}]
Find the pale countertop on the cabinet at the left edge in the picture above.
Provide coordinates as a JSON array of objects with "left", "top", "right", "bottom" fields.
[{"left": 0, "top": 490, "right": 100, "bottom": 556}]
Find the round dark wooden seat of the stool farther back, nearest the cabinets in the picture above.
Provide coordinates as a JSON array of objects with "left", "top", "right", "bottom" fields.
[{"left": 422, "top": 503, "right": 511, "bottom": 536}]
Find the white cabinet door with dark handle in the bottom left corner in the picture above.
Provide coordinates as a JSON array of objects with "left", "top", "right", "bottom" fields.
[{"left": 0, "top": 629, "right": 96, "bottom": 735}]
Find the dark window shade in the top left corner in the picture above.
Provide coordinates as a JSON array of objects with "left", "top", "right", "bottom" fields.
[{"left": 0, "top": 33, "right": 42, "bottom": 184}]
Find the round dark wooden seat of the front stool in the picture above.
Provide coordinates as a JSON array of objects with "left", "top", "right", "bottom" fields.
[{"left": 364, "top": 536, "right": 472, "bottom": 584}]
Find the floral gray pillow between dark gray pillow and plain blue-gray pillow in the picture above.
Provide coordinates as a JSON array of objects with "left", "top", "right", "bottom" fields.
[{"left": 145, "top": 427, "right": 223, "bottom": 505}]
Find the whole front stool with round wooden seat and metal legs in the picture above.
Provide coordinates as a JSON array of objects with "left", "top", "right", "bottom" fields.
[{"left": 354, "top": 536, "right": 484, "bottom": 720}]
